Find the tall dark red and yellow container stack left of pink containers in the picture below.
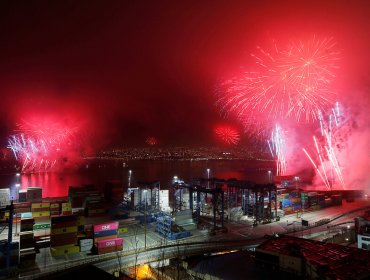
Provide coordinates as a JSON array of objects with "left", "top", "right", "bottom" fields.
[{"left": 50, "top": 215, "right": 80, "bottom": 257}]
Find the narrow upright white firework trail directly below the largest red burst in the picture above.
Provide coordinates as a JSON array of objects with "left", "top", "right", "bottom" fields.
[{"left": 267, "top": 124, "right": 286, "bottom": 176}]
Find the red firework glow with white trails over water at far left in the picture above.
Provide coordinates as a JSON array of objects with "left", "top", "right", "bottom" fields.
[{"left": 8, "top": 121, "right": 76, "bottom": 173}]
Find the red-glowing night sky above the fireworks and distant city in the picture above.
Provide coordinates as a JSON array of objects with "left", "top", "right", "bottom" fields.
[{"left": 0, "top": 0, "right": 370, "bottom": 149}]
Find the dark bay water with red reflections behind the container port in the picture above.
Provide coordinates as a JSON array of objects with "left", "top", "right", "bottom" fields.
[{"left": 0, "top": 160, "right": 271, "bottom": 197}]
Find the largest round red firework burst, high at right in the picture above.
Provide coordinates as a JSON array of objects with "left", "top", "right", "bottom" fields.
[{"left": 216, "top": 37, "right": 339, "bottom": 135}]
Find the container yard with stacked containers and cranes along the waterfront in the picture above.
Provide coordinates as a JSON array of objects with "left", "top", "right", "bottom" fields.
[{"left": 1, "top": 179, "right": 367, "bottom": 278}]
